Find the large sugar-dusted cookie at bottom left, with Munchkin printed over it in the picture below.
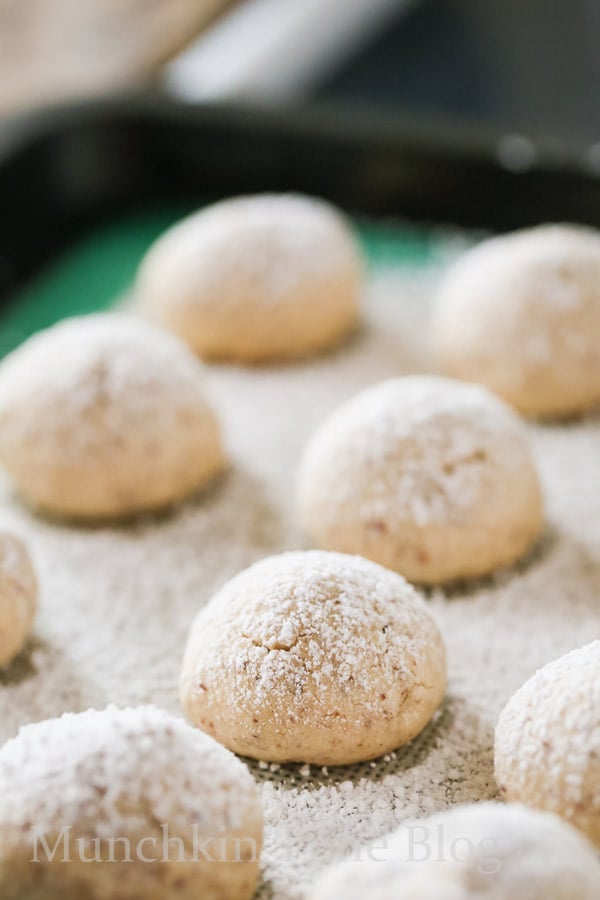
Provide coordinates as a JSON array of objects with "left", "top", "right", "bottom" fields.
[{"left": 0, "top": 707, "right": 262, "bottom": 900}]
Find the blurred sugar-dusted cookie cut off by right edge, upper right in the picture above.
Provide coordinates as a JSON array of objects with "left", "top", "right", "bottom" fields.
[{"left": 433, "top": 225, "right": 600, "bottom": 416}]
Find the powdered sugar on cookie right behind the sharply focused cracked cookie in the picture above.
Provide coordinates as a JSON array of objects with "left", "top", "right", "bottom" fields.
[{"left": 300, "top": 376, "right": 528, "bottom": 526}]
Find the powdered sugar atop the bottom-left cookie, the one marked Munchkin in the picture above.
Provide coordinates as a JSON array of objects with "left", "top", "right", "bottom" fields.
[{"left": 0, "top": 707, "right": 256, "bottom": 838}]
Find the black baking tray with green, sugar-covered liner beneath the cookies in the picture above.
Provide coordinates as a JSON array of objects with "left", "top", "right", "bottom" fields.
[{"left": 0, "top": 98, "right": 600, "bottom": 900}]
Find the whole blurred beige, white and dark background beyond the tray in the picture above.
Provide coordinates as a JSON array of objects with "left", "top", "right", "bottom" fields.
[{"left": 0, "top": 0, "right": 600, "bottom": 147}]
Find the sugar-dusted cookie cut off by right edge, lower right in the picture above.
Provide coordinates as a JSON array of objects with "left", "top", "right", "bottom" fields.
[{"left": 495, "top": 641, "right": 600, "bottom": 848}]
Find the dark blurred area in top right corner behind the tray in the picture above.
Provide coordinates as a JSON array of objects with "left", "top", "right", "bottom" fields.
[{"left": 317, "top": 0, "right": 600, "bottom": 142}]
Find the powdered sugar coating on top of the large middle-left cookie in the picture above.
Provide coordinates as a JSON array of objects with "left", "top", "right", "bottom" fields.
[{"left": 0, "top": 313, "right": 216, "bottom": 466}]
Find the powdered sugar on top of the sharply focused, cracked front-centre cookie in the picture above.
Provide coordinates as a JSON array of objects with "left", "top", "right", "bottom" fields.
[{"left": 191, "top": 550, "right": 443, "bottom": 721}]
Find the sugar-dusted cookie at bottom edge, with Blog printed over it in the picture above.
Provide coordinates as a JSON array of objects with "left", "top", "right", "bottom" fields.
[{"left": 308, "top": 803, "right": 600, "bottom": 900}]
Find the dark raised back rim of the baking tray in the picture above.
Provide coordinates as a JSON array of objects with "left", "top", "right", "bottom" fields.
[{"left": 0, "top": 95, "right": 600, "bottom": 299}]
